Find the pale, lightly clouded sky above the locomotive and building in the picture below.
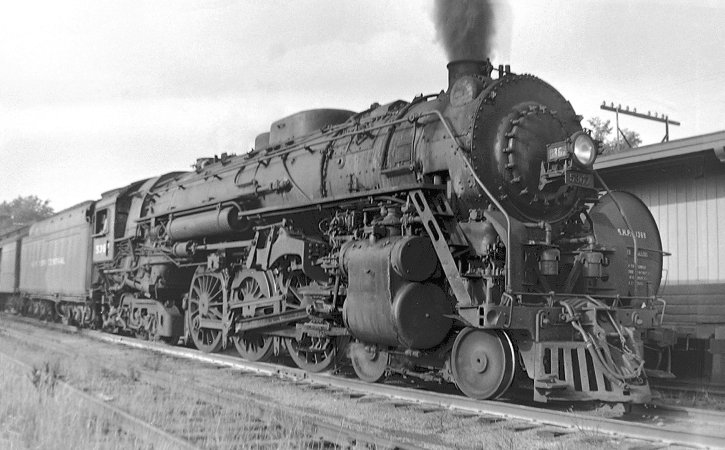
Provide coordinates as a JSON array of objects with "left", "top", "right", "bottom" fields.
[{"left": 0, "top": 0, "right": 725, "bottom": 210}]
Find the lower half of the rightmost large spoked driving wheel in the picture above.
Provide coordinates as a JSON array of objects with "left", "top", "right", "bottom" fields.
[{"left": 287, "top": 335, "right": 347, "bottom": 372}]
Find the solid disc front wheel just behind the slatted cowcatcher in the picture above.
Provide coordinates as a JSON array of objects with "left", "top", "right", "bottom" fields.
[{"left": 451, "top": 328, "right": 516, "bottom": 400}]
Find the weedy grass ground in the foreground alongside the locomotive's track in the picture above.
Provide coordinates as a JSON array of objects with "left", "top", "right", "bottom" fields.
[{"left": 0, "top": 324, "right": 632, "bottom": 450}]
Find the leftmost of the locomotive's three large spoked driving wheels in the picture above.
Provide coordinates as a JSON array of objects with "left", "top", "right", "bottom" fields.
[{"left": 189, "top": 272, "right": 227, "bottom": 353}]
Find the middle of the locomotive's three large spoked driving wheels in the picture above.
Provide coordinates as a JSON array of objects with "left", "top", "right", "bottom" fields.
[{"left": 232, "top": 271, "right": 274, "bottom": 361}]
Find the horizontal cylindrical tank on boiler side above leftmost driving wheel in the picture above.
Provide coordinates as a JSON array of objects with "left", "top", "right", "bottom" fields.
[{"left": 167, "top": 206, "right": 246, "bottom": 241}]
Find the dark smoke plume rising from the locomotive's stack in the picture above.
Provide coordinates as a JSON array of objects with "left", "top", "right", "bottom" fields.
[{"left": 433, "top": 0, "right": 497, "bottom": 61}]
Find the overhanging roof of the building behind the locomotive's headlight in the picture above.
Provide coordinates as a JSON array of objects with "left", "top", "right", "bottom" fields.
[{"left": 594, "top": 130, "right": 725, "bottom": 170}]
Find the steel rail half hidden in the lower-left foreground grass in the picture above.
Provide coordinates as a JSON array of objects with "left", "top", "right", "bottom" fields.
[{"left": 0, "top": 352, "right": 199, "bottom": 450}]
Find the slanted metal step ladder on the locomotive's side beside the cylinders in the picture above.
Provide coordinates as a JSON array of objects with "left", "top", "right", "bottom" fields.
[{"left": 409, "top": 189, "right": 475, "bottom": 307}]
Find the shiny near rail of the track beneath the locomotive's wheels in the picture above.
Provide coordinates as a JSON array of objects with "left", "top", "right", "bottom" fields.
[{"left": 1, "top": 312, "right": 725, "bottom": 448}]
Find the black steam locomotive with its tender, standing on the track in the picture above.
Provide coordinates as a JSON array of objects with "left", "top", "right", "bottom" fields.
[{"left": 0, "top": 60, "right": 663, "bottom": 402}]
